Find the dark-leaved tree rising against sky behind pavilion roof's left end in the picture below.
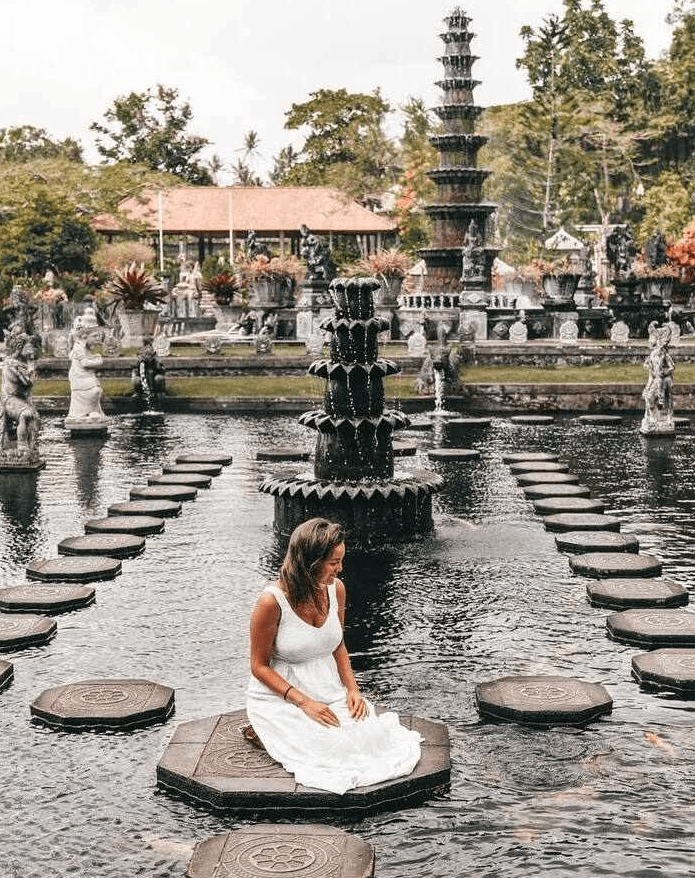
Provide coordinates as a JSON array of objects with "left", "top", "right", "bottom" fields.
[{"left": 90, "top": 84, "right": 212, "bottom": 186}]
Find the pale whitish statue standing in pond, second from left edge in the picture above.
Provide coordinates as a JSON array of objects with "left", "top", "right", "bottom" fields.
[{"left": 64, "top": 317, "right": 108, "bottom": 432}]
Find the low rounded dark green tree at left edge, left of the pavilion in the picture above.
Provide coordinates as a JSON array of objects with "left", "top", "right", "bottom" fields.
[{"left": 0, "top": 191, "right": 97, "bottom": 276}]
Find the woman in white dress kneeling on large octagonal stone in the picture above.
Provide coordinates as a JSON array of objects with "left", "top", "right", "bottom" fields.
[{"left": 246, "top": 518, "right": 421, "bottom": 794}]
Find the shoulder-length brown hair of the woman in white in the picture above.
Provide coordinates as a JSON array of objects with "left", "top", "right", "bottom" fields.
[{"left": 280, "top": 518, "right": 345, "bottom": 607}]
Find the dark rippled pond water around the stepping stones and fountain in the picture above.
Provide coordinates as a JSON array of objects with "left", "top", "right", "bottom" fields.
[{"left": 0, "top": 415, "right": 695, "bottom": 878}]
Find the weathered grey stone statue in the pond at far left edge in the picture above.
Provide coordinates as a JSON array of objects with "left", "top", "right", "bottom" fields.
[{"left": 0, "top": 324, "right": 44, "bottom": 460}]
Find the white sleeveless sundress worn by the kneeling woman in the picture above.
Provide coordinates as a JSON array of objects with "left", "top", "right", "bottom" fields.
[{"left": 246, "top": 580, "right": 422, "bottom": 795}]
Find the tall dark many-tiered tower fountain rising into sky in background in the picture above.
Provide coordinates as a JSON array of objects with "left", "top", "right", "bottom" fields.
[{"left": 402, "top": 7, "right": 498, "bottom": 338}]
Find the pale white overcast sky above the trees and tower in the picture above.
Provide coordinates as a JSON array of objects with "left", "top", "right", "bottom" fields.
[{"left": 0, "top": 0, "right": 673, "bottom": 180}]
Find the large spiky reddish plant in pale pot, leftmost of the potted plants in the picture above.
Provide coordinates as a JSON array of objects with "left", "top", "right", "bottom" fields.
[{"left": 106, "top": 262, "right": 166, "bottom": 347}]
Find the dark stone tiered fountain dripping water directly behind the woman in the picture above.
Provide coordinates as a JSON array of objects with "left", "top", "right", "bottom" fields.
[{"left": 260, "top": 278, "right": 441, "bottom": 545}]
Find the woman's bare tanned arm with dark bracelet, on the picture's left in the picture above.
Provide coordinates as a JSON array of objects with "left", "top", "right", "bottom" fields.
[{"left": 250, "top": 592, "right": 340, "bottom": 726}]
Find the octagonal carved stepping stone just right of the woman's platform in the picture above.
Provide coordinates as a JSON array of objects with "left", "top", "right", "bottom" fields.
[{"left": 475, "top": 676, "right": 613, "bottom": 726}]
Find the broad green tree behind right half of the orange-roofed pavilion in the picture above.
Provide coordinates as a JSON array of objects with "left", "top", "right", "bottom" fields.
[{"left": 282, "top": 88, "right": 397, "bottom": 199}]
